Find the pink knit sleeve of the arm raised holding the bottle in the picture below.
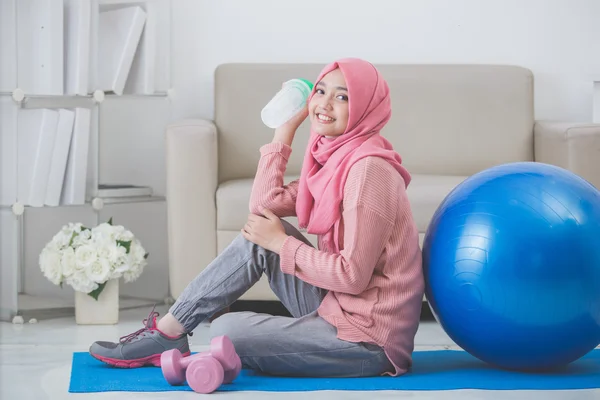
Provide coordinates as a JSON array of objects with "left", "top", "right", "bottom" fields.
[{"left": 250, "top": 142, "right": 298, "bottom": 218}]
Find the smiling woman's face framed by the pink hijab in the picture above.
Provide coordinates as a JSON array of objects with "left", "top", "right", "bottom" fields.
[{"left": 308, "top": 68, "right": 348, "bottom": 138}]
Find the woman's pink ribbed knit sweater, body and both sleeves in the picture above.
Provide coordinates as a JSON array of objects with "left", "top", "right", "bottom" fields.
[{"left": 250, "top": 142, "right": 424, "bottom": 376}]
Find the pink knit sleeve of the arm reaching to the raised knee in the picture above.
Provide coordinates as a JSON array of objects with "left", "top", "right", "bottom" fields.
[{"left": 279, "top": 161, "right": 398, "bottom": 295}]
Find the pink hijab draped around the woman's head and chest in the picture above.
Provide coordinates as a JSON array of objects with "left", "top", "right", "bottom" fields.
[{"left": 296, "top": 58, "right": 411, "bottom": 241}]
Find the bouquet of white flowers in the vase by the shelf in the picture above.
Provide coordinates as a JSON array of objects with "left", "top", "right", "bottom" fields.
[{"left": 39, "top": 218, "right": 148, "bottom": 300}]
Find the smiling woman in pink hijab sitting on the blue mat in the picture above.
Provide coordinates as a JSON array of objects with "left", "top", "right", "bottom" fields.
[{"left": 90, "top": 59, "right": 424, "bottom": 377}]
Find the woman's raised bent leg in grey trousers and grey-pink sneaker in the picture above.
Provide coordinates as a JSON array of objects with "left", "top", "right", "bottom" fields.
[{"left": 90, "top": 221, "right": 326, "bottom": 367}]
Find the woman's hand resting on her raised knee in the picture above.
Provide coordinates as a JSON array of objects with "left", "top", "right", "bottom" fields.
[{"left": 242, "top": 208, "right": 288, "bottom": 254}]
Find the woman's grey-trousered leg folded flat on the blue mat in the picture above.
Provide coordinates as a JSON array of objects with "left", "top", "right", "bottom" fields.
[{"left": 211, "top": 311, "right": 394, "bottom": 377}]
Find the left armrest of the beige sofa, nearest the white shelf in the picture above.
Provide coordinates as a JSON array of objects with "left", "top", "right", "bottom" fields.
[{"left": 165, "top": 119, "right": 218, "bottom": 298}]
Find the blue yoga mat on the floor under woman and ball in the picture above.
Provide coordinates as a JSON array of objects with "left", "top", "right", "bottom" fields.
[{"left": 69, "top": 349, "right": 600, "bottom": 393}]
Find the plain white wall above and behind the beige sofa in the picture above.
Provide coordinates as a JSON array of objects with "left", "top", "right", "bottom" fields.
[{"left": 172, "top": 0, "right": 600, "bottom": 121}]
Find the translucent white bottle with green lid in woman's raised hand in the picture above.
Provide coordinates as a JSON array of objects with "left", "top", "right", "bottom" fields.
[{"left": 260, "top": 79, "right": 313, "bottom": 129}]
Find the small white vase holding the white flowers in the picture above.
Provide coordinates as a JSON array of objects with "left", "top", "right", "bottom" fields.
[{"left": 75, "top": 279, "right": 119, "bottom": 325}]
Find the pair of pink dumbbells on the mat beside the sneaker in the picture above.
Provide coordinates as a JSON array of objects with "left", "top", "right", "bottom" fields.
[{"left": 160, "top": 336, "right": 242, "bottom": 393}]
